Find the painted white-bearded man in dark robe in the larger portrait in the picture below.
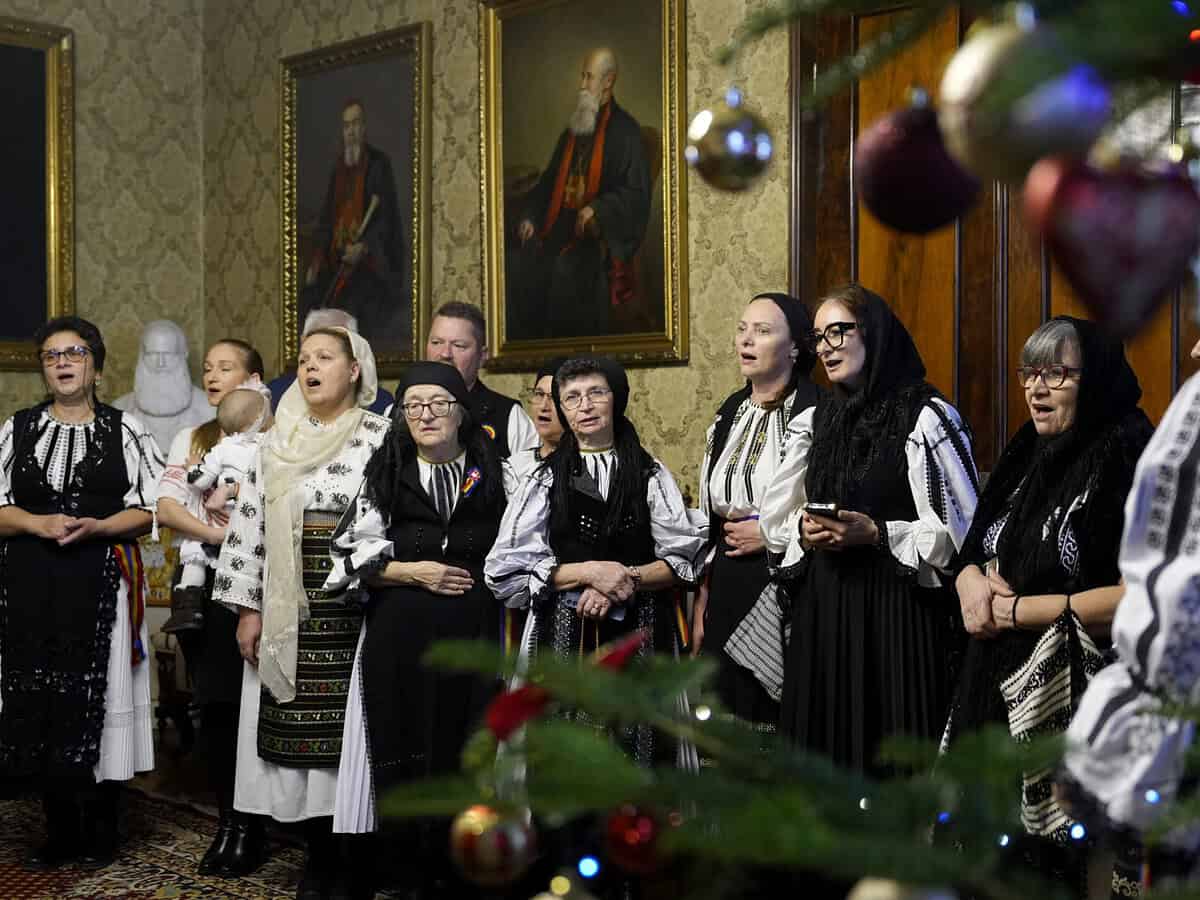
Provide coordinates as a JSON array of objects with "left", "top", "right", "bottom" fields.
[{"left": 509, "top": 47, "right": 650, "bottom": 338}]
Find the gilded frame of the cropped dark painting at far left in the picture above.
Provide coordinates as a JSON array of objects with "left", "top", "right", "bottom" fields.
[{"left": 0, "top": 17, "right": 74, "bottom": 371}]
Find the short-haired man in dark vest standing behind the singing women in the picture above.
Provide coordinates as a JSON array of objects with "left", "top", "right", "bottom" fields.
[{"left": 425, "top": 300, "right": 539, "bottom": 458}]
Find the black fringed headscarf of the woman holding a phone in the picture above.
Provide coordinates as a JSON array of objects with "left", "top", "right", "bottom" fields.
[{"left": 805, "top": 288, "right": 938, "bottom": 515}]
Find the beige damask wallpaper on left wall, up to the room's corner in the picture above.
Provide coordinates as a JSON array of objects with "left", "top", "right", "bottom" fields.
[{"left": 0, "top": 0, "right": 204, "bottom": 416}]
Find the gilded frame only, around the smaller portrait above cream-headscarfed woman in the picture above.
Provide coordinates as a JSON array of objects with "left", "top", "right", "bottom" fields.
[{"left": 280, "top": 22, "right": 432, "bottom": 376}]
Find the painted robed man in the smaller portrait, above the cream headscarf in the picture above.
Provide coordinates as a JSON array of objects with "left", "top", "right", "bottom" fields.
[{"left": 301, "top": 100, "right": 410, "bottom": 343}]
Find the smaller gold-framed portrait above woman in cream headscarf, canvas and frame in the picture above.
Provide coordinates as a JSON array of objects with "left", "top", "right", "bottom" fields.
[{"left": 280, "top": 22, "right": 431, "bottom": 376}]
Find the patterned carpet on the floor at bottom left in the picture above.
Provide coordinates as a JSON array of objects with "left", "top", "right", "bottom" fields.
[{"left": 0, "top": 791, "right": 304, "bottom": 900}]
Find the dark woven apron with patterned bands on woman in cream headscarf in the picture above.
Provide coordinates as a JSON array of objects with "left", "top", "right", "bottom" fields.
[{"left": 258, "top": 512, "right": 362, "bottom": 769}]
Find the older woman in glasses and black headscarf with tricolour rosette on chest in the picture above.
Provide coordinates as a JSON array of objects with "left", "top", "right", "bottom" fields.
[{"left": 325, "top": 362, "right": 515, "bottom": 896}]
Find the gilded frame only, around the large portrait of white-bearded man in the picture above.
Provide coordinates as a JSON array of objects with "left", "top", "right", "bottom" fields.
[{"left": 479, "top": 0, "right": 689, "bottom": 371}]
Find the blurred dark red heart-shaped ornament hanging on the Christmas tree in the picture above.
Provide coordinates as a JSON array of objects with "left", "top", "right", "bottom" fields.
[{"left": 1025, "top": 160, "right": 1200, "bottom": 337}]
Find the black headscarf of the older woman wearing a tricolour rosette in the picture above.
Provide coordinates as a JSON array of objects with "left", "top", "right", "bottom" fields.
[{"left": 362, "top": 362, "right": 504, "bottom": 515}]
